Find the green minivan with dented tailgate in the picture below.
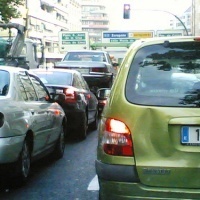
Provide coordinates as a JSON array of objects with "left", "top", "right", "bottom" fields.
[{"left": 95, "top": 36, "right": 200, "bottom": 200}]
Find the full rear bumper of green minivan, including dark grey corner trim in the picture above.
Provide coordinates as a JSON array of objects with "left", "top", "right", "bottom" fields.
[{"left": 95, "top": 160, "right": 200, "bottom": 200}]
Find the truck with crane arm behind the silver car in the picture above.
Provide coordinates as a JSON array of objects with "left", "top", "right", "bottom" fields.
[{"left": 0, "top": 23, "right": 44, "bottom": 69}]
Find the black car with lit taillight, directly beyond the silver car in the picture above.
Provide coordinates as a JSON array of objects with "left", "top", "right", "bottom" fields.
[{"left": 32, "top": 68, "right": 98, "bottom": 139}]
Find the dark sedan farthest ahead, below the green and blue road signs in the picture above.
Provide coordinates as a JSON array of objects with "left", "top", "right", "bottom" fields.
[{"left": 54, "top": 50, "right": 115, "bottom": 92}]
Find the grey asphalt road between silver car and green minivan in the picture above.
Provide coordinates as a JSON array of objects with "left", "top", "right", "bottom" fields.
[{"left": 0, "top": 131, "right": 98, "bottom": 200}]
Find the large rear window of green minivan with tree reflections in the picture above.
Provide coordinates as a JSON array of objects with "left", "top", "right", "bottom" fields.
[{"left": 126, "top": 42, "right": 200, "bottom": 107}]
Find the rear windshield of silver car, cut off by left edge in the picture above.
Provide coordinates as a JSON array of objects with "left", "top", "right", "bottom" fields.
[{"left": 0, "top": 70, "right": 10, "bottom": 96}]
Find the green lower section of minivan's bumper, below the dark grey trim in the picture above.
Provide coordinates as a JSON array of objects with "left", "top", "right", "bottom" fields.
[{"left": 99, "top": 179, "right": 200, "bottom": 200}]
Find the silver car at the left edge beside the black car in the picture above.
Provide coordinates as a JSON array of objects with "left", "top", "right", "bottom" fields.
[{"left": 0, "top": 66, "right": 66, "bottom": 184}]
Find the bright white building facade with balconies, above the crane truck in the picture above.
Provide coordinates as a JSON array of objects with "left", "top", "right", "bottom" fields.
[{"left": 12, "top": 0, "right": 81, "bottom": 58}]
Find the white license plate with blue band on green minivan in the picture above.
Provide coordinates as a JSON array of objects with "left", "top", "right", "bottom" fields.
[{"left": 181, "top": 126, "right": 200, "bottom": 146}]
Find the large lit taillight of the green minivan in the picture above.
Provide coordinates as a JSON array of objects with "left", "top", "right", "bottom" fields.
[{"left": 102, "top": 119, "right": 133, "bottom": 156}]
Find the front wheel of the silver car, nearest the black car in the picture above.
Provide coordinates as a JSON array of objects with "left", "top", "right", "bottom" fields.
[{"left": 53, "top": 125, "right": 65, "bottom": 160}]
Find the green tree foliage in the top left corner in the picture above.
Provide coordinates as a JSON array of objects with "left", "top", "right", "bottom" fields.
[{"left": 0, "top": 0, "right": 24, "bottom": 23}]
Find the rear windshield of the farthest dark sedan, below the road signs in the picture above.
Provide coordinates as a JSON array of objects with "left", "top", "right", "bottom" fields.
[{"left": 63, "top": 52, "right": 106, "bottom": 62}]
